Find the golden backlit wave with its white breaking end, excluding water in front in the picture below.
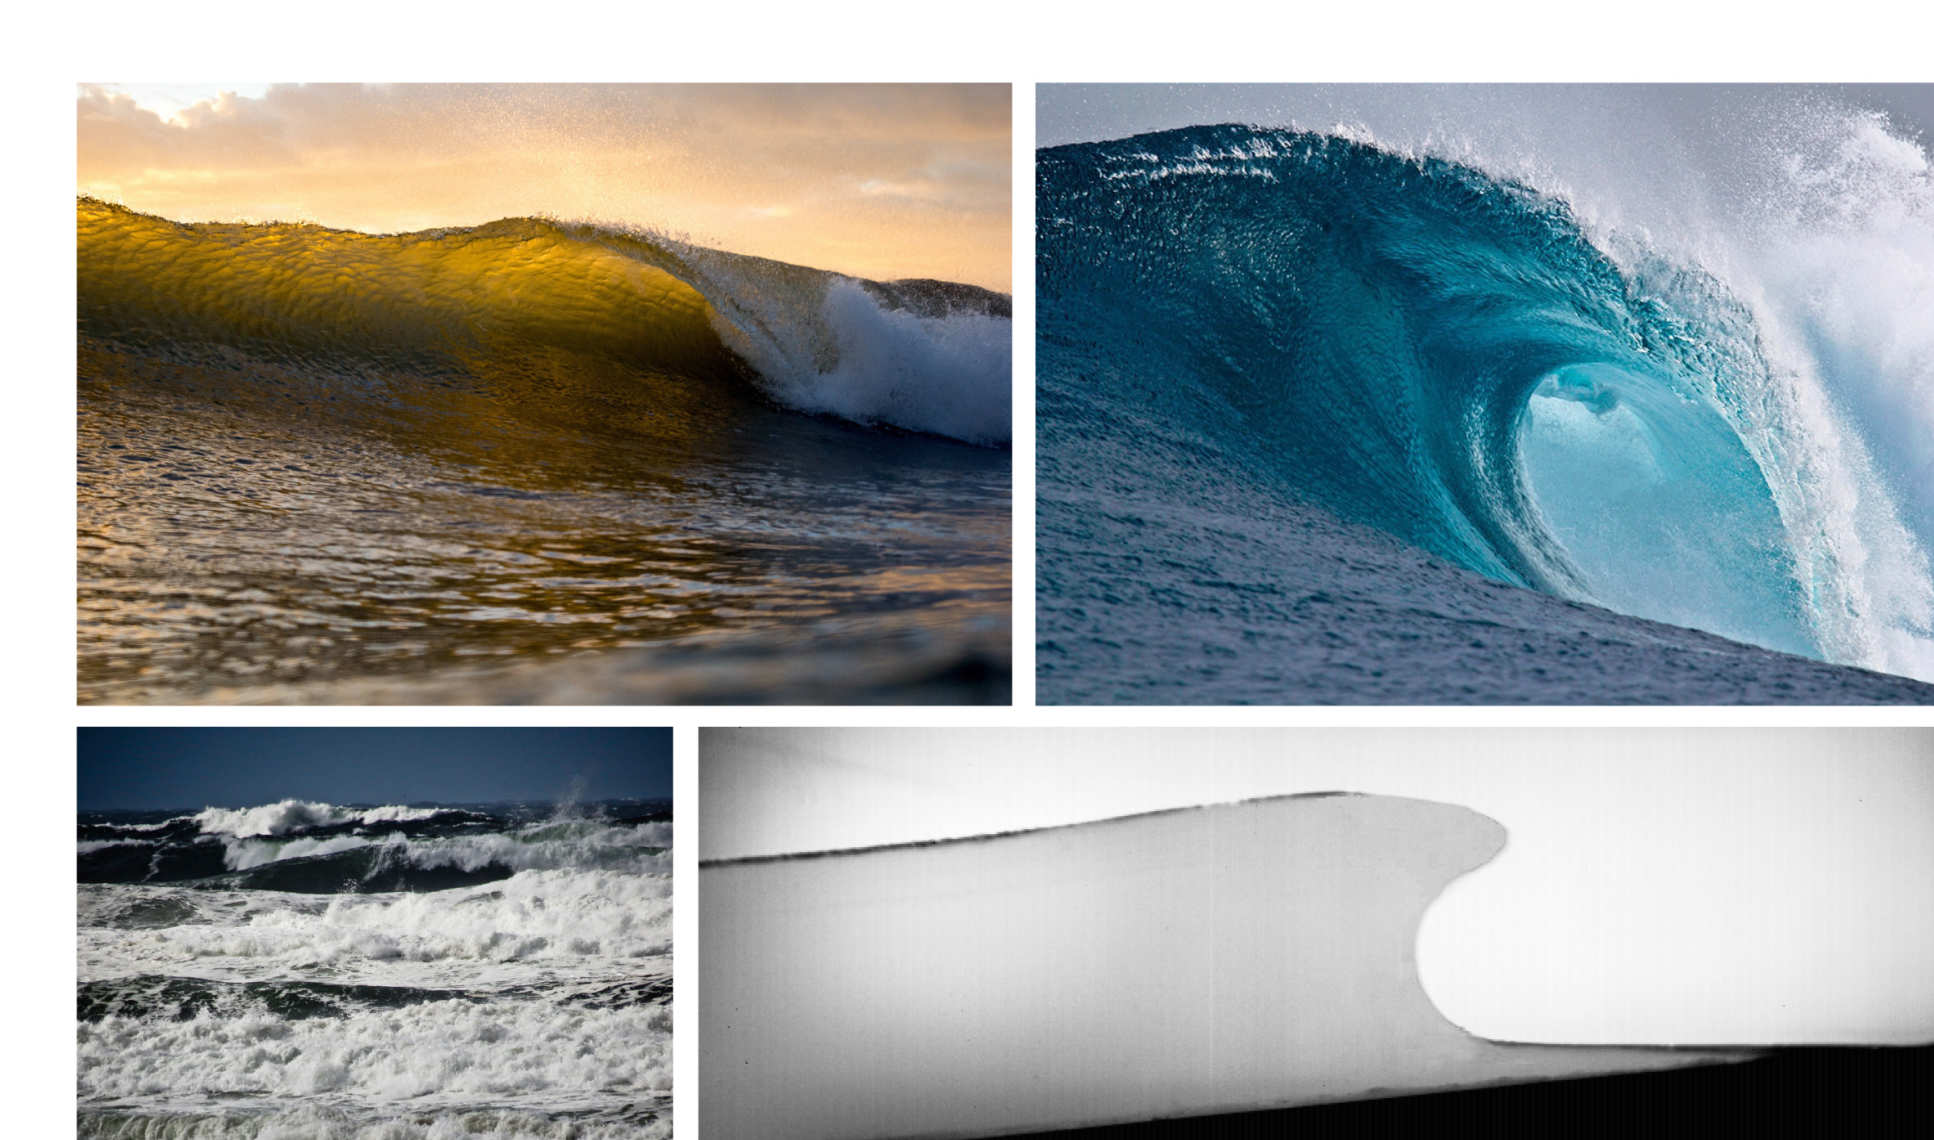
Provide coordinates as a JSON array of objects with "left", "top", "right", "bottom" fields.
[{"left": 75, "top": 197, "right": 1011, "bottom": 447}]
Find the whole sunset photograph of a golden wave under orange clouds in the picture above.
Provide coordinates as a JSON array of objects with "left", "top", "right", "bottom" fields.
[{"left": 75, "top": 83, "right": 1013, "bottom": 705}]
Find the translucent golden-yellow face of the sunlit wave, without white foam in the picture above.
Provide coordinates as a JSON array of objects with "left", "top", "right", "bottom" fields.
[{"left": 77, "top": 197, "right": 731, "bottom": 375}]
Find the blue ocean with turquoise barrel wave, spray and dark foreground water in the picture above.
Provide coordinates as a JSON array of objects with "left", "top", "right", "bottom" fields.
[{"left": 1037, "top": 110, "right": 1934, "bottom": 703}]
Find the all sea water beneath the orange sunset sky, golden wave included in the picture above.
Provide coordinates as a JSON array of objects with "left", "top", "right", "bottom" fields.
[{"left": 77, "top": 199, "right": 1011, "bottom": 703}]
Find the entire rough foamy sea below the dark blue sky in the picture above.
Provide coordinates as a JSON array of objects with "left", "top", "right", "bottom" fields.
[{"left": 75, "top": 801, "right": 671, "bottom": 1140}]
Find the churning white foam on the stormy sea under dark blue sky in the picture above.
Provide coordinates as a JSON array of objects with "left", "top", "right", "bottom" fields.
[{"left": 77, "top": 801, "right": 671, "bottom": 1140}]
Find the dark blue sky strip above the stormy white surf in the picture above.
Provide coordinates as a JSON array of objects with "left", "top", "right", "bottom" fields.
[{"left": 77, "top": 728, "right": 671, "bottom": 811}]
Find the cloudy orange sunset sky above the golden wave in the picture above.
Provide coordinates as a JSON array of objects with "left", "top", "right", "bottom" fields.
[{"left": 77, "top": 83, "right": 1011, "bottom": 290}]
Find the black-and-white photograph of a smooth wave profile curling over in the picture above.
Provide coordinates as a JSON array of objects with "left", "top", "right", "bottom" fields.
[{"left": 698, "top": 728, "right": 1934, "bottom": 1140}]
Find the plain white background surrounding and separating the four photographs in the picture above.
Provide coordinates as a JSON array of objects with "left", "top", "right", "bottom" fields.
[{"left": 22, "top": 0, "right": 1934, "bottom": 1138}]
